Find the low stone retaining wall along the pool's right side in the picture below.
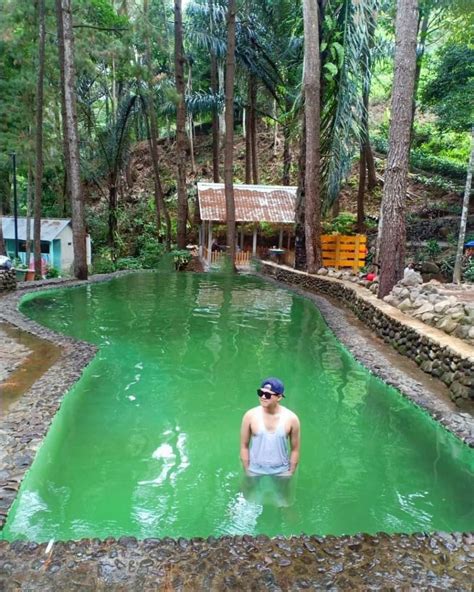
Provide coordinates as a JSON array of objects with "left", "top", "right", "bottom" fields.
[{"left": 262, "top": 262, "right": 474, "bottom": 401}]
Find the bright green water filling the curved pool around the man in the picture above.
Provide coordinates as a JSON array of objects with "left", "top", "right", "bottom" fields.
[{"left": 1, "top": 273, "right": 474, "bottom": 541}]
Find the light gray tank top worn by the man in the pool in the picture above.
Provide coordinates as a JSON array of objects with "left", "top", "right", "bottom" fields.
[{"left": 249, "top": 407, "right": 290, "bottom": 475}]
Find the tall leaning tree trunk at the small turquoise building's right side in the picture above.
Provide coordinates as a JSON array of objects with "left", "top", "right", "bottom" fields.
[{"left": 56, "top": 0, "right": 87, "bottom": 280}]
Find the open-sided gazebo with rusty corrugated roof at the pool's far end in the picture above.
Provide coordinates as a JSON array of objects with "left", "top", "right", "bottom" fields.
[{"left": 198, "top": 183, "right": 297, "bottom": 267}]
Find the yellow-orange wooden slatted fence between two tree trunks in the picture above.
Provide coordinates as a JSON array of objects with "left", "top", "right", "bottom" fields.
[{"left": 321, "top": 234, "right": 367, "bottom": 271}]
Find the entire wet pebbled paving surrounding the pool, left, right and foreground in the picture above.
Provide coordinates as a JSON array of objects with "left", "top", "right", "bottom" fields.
[{"left": 0, "top": 276, "right": 474, "bottom": 592}]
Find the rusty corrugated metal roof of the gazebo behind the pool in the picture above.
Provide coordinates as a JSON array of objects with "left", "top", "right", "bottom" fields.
[{"left": 198, "top": 183, "right": 297, "bottom": 224}]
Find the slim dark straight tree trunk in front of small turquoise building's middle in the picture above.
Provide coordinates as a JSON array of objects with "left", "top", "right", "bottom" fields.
[{"left": 33, "top": 0, "right": 46, "bottom": 280}]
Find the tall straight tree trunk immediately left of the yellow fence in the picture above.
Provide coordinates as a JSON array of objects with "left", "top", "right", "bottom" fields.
[{"left": 303, "top": 0, "right": 321, "bottom": 273}]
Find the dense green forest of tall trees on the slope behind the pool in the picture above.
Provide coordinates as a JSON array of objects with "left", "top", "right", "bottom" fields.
[{"left": 0, "top": 0, "right": 474, "bottom": 297}]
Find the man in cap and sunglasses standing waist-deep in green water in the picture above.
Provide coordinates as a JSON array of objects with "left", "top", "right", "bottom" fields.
[{"left": 240, "top": 378, "right": 300, "bottom": 477}]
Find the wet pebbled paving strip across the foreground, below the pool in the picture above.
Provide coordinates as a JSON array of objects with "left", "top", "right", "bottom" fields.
[{"left": 0, "top": 534, "right": 474, "bottom": 592}]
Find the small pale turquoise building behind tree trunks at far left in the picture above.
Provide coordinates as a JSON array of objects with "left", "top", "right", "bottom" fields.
[{"left": 1, "top": 216, "right": 91, "bottom": 272}]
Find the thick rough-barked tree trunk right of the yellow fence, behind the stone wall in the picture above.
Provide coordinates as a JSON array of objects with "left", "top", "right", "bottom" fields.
[{"left": 378, "top": 0, "right": 418, "bottom": 298}]
